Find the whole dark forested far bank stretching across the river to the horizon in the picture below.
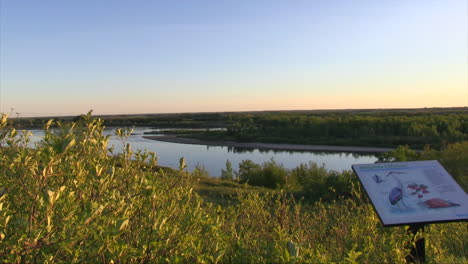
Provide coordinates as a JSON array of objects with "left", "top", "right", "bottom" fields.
[{"left": 13, "top": 107, "right": 468, "bottom": 149}]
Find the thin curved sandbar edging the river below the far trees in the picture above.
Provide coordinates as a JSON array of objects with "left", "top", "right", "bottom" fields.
[{"left": 143, "top": 135, "right": 394, "bottom": 153}]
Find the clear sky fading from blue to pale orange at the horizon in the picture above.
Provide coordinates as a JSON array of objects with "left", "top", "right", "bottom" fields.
[{"left": 0, "top": 0, "right": 468, "bottom": 117}]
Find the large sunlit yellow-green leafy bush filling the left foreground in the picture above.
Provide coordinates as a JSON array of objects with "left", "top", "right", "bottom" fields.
[{"left": 0, "top": 112, "right": 220, "bottom": 263}]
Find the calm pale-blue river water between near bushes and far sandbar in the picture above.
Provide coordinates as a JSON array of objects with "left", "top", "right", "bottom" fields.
[{"left": 27, "top": 128, "right": 377, "bottom": 177}]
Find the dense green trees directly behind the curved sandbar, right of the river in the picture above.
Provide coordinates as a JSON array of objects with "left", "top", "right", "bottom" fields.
[{"left": 220, "top": 110, "right": 468, "bottom": 149}]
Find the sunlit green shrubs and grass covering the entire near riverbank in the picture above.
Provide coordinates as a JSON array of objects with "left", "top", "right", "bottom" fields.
[{"left": 0, "top": 114, "right": 468, "bottom": 263}]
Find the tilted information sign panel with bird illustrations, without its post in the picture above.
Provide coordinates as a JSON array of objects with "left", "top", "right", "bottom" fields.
[{"left": 352, "top": 160, "right": 468, "bottom": 226}]
